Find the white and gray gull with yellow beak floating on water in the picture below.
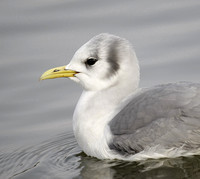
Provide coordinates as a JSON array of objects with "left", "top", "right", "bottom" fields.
[{"left": 40, "top": 33, "right": 200, "bottom": 161}]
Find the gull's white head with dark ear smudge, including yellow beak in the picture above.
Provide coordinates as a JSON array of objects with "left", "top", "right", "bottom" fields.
[{"left": 41, "top": 33, "right": 139, "bottom": 91}]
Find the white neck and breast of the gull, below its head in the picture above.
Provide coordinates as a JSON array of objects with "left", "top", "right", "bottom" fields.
[{"left": 73, "top": 53, "right": 139, "bottom": 159}]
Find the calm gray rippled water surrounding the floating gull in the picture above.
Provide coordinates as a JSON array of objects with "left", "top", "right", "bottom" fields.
[{"left": 0, "top": 0, "right": 200, "bottom": 179}]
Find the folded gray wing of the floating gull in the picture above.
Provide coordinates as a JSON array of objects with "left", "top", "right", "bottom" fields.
[{"left": 109, "top": 82, "right": 200, "bottom": 154}]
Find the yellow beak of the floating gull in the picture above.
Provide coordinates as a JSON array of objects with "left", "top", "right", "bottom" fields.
[{"left": 40, "top": 66, "right": 78, "bottom": 80}]
